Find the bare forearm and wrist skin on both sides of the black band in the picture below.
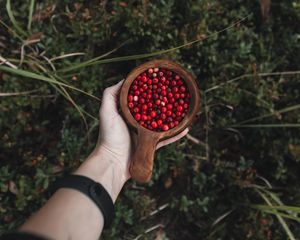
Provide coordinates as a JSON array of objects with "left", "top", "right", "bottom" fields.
[{"left": 20, "top": 151, "right": 127, "bottom": 239}]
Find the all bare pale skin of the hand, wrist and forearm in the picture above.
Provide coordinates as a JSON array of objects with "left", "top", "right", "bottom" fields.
[{"left": 19, "top": 81, "right": 188, "bottom": 240}]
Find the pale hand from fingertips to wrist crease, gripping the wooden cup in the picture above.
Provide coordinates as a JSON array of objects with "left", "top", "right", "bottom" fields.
[{"left": 97, "top": 81, "right": 188, "bottom": 179}]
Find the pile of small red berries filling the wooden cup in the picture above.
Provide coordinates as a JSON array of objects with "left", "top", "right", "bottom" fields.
[{"left": 128, "top": 68, "right": 191, "bottom": 131}]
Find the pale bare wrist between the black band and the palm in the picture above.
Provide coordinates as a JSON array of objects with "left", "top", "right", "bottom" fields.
[{"left": 75, "top": 149, "right": 127, "bottom": 202}]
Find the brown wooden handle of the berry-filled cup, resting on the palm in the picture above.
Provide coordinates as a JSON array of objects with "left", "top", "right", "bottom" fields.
[{"left": 129, "top": 128, "right": 159, "bottom": 183}]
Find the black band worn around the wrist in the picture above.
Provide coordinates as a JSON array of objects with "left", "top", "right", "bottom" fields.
[{"left": 50, "top": 175, "right": 115, "bottom": 228}]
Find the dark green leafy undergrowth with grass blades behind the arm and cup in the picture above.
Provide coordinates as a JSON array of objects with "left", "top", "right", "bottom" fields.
[{"left": 0, "top": 0, "right": 300, "bottom": 239}]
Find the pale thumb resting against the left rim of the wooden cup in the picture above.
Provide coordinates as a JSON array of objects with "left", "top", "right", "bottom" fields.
[{"left": 101, "top": 80, "right": 124, "bottom": 111}]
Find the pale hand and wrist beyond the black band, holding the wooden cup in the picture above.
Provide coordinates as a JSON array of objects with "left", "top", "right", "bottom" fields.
[{"left": 75, "top": 81, "right": 188, "bottom": 201}]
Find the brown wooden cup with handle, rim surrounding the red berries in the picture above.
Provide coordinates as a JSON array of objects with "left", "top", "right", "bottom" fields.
[{"left": 120, "top": 60, "right": 200, "bottom": 183}]
